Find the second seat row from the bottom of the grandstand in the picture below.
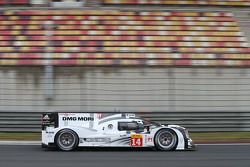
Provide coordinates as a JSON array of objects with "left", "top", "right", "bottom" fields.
[{"left": 0, "top": 53, "right": 250, "bottom": 60}]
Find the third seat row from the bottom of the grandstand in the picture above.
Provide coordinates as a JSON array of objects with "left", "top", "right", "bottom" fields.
[{"left": 0, "top": 46, "right": 250, "bottom": 54}]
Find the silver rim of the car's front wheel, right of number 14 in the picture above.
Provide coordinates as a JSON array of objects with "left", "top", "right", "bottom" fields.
[{"left": 158, "top": 131, "right": 176, "bottom": 149}]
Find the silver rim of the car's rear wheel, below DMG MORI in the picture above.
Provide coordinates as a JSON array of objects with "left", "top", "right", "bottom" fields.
[{"left": 58, "top": 132, "right": 75, "bottom": 150}]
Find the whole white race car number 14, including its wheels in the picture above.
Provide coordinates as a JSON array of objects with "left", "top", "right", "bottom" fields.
[{"left": 42, "top": 113, "right": 195, "bottom": 151}]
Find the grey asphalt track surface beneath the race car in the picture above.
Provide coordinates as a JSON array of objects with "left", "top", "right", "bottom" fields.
[{"left": 0, "top": 145, "right": 250, "bottom": 167}]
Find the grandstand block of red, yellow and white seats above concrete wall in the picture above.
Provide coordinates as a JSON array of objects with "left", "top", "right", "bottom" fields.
[{"left": 0, "top": 10, "right": 250, "bottom": 66}]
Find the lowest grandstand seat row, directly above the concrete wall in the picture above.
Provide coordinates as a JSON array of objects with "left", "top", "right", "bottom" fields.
[{"left": 0, "top": 59, "right": 250, "bottom": 67}]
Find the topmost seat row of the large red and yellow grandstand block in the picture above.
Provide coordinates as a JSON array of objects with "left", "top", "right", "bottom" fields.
[{"left": 1, "top": 9, "right": 236, "bottom": 16}]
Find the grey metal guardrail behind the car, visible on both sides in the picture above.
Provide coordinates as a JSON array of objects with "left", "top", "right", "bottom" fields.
[{"left": 0, "top": 111, "right": 250, "bottom": 132}]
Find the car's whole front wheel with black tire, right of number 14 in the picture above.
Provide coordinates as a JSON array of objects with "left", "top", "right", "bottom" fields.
[{"left": 154, "top": 129, "right": 178, "bottom": 151}]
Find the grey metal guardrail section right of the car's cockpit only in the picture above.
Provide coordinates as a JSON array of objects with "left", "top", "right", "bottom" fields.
[{"left": 140, "top": 111, "right": 250, "bottom": 132}]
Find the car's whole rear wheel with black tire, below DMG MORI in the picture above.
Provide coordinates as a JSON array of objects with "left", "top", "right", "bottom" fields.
[{"left": 55, "top": 129, "right": 79, "bottom": 151}]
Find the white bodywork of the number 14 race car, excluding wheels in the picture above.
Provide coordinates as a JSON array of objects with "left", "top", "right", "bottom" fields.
[{"left": 42, "top": 113, "right": 193, "bottom": 150}]
